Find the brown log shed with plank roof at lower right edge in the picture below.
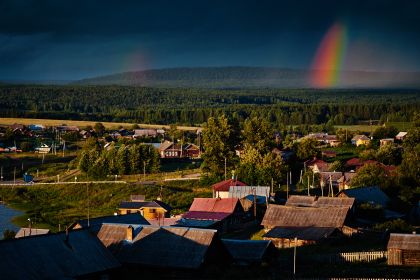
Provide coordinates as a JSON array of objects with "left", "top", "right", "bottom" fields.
[{"left": 388, "top": 233, "right": 420, "bottom": 266}]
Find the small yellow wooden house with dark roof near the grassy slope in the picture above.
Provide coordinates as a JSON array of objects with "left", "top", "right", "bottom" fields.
[{"left": 118, "top": 200, "right": 172, "bottom": 220}]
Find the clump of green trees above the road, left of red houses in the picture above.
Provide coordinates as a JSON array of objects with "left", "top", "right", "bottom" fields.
[{"left": 78, "top": 138, "right": 159, "bottom": 179}]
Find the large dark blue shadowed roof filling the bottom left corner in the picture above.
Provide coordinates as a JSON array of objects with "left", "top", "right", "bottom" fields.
[{"left": 0, "top": 230, "right": 120, "bottom": 279}]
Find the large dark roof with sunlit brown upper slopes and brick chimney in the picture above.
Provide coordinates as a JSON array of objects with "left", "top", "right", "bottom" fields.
[{"left": 98, "top": 224, "right": 217, "bottom": 268}]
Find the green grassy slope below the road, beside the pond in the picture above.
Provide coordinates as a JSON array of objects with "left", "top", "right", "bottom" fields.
[{"left": 0, "top": 181, "right": 211, "bottom": 231}]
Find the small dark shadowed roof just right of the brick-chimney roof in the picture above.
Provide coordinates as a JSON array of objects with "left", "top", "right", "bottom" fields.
[{"left": 222, "top": 239, "right": 273, "bottom": 261}]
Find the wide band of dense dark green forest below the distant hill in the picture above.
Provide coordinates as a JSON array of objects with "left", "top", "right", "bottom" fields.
[{"left": 0, "top": 85, "right": 420, "bottom": 125}]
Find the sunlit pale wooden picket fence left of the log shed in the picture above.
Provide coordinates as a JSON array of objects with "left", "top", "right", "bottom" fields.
[{"left": 315, "top": 251, "right": 388, "bottom": 264}]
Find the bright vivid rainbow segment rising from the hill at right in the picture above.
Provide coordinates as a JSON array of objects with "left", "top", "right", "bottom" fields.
[{"left": 310, "top": 22, "right": 347, "bottom": 88}]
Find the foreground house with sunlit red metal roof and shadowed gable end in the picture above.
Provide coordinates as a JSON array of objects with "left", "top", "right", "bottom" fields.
[{"left": 177, "top": 198, "right": 245, "bottom": 233}]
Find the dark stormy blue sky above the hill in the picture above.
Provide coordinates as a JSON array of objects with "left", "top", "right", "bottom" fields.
[{"left": 0, "top": 0, "right": 420, "bottom": 81}]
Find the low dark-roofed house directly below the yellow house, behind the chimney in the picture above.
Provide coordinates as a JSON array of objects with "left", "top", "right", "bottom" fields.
[{"left": 69, "top": 213, "right": 149, "bottom": 234}]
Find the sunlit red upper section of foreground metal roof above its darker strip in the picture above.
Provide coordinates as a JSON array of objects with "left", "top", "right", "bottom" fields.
[{"left": 189, "top": 198, "right": 239, "bottom": 214}]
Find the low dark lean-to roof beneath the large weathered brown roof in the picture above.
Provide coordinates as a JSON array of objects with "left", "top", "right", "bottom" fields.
[{"left": 263, "top": 227, "right": 336, "bottom": 241}]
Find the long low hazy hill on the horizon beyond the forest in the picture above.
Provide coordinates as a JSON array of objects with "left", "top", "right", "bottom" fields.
[{"left": 74, "top": 67, "right": 420, "bottom": 88}]
